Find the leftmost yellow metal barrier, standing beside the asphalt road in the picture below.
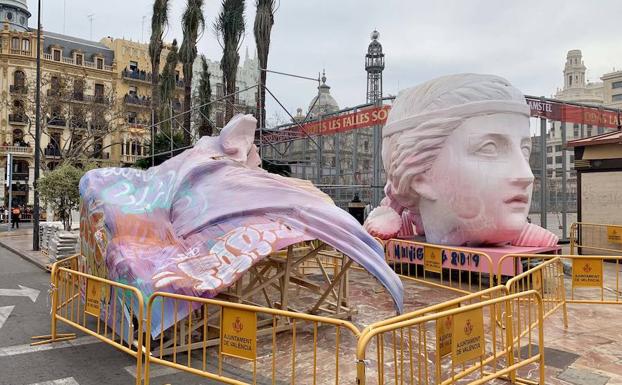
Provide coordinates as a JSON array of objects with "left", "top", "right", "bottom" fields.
[{"left": 32, "top": 256, "right": 144, "bottom": 385}]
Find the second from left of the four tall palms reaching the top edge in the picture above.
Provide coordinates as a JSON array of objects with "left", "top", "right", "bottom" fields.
[{"left": 179, "top": 0, "right": 205, "bottom": 146}]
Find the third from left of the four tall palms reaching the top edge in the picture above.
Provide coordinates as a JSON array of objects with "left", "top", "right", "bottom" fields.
[{"left": 214, "top": 0, "right": 245, "bottom": 124}]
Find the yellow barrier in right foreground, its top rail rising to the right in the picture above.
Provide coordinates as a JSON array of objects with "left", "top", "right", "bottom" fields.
[{"left": 357, "top": 286, "right": 544, "bottom": 385}]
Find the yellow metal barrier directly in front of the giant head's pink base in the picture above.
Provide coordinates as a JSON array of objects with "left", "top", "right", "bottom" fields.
[{"left": 384, "top": 239, "right": 495, "bottom": 294}]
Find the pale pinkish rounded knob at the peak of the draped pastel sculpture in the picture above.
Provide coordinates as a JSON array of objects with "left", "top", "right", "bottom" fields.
[{"left": 219, "top": 115, "right": 257, "bottom": 162}]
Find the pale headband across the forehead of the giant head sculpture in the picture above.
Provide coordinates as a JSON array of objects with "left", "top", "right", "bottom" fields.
[{"left": 382, "top": 100, "right": 530, "bottom": 138}]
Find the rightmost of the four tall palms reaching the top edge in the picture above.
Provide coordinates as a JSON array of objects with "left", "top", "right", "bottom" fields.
[{"left": 253, "top": 0, "right": 276, "bottom": 127}]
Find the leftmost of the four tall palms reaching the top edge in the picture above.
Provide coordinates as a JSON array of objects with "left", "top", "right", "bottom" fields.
[{"left": 149, "top": 0, "right": 168, "bottom": 133}]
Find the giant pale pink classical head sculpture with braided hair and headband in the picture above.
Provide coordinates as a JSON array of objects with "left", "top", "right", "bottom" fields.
[{"left": 365, "top": 74, "right": 558, "bottom": 246}]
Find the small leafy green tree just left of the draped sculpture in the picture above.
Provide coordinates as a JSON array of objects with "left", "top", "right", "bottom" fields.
[{"left": 37, "top": 163, "right": 94, "bottom": 230}]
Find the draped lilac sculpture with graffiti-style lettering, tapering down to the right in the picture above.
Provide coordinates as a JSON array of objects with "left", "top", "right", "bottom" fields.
[{"left": 80, "top": 115, "right": 403, "bottom": 331}]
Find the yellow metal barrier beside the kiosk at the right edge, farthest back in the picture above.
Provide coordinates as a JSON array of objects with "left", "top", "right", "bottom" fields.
[{"left": 570, "top": 222, "right": 622, "bottom": 255}]
